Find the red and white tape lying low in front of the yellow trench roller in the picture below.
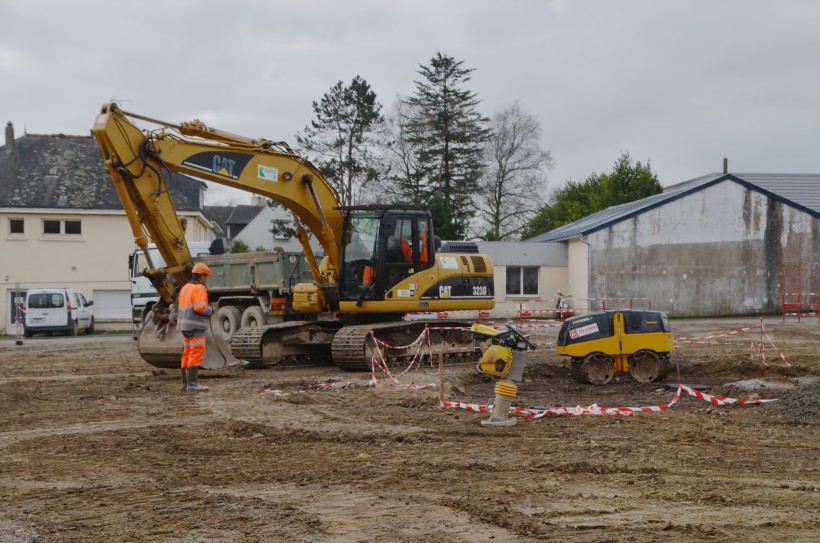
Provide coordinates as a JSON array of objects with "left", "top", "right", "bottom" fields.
[{"left": 440, "top": 385, "right": 777, "bottom": 419}]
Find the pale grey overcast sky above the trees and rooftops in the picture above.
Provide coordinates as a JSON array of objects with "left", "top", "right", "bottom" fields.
[{"left": 0, "top": 0, "right": 820, "bottom": 203}]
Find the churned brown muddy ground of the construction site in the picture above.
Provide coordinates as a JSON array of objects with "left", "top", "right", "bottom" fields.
[{"left": 0, "top": 318, "right": 820, "bottom": 543}]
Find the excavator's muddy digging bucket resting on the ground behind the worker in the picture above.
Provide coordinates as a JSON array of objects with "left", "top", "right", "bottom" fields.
[{"left": 137, "top": 312, "right": 241, "bottom": 370}]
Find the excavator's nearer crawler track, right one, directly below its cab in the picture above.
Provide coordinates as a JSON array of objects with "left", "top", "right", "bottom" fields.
[{"left": 333, "top": 321, "right": 481, "bottom": 371}]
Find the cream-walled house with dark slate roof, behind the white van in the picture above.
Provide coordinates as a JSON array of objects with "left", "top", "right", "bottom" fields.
[{"left": 0, "top": 123, "right": 214, "bottom": 334}]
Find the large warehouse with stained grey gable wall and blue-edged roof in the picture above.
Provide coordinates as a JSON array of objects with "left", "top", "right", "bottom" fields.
[{"left": 528, "top": 173, "right": 820, "bottom": 317}]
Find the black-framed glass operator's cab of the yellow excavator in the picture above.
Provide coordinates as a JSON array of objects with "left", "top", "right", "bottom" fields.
[{"left": 339, "top": 206, "right": 434, "bottom": 303}]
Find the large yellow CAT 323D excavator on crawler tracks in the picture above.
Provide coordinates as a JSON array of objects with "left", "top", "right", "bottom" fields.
[{"left": 92, "top": 103, "right": 494, "bottom": 370}]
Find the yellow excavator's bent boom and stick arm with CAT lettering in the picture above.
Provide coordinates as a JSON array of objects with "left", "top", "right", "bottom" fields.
[{"left": 92, "top": 103, "right": 344, "bottom": 303}]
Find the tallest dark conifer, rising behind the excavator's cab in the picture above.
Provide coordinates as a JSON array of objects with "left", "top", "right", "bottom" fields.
[{"left": 406, "top": 52, "right": 490, "bottom": 240}]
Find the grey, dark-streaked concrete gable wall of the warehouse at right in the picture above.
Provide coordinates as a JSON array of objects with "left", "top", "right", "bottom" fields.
[{"left": 588, "top": 180, "right": 820, "bottom": 317}]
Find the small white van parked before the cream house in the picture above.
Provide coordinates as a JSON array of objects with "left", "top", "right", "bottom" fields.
[{"left": 23, "top": 288, "right": 94, "bottom": 337}]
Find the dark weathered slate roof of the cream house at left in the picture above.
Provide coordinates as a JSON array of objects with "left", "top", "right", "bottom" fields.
[{"left": 0, "top": 134, "right": 206, "bottom": 211}]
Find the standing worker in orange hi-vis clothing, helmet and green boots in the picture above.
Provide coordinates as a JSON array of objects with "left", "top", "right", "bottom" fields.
[{"left": 177, "top": 262, "right": 214, "bottom": 392}]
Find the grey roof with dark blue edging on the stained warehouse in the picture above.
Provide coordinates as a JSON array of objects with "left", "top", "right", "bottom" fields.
[{"left": 526, "top": 173, "right": 820, "bottom": 242}]
